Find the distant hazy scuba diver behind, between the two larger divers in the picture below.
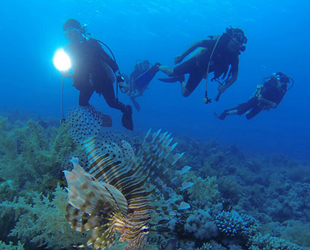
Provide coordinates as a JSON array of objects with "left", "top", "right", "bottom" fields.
[{"left": 122, "top": 60, "right": 160, "bottom": 111}]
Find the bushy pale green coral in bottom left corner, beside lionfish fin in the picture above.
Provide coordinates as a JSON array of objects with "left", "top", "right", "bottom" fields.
[{"left": 0, "top": 186, "right": 89, "bottom": 249}]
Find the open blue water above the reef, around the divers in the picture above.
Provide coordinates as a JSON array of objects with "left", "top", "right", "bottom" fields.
[{"left": 0, "top": 0, "right": 310, "bottom": 159}]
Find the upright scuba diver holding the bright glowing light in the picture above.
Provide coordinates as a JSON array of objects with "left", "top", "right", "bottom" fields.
[{"left": 63, "top": 19, "right": 133, "bottom": 130}]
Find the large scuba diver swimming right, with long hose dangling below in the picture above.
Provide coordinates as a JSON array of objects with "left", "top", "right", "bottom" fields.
[{"left": 159, "top": 27, "right": 247, "bottom": 104}]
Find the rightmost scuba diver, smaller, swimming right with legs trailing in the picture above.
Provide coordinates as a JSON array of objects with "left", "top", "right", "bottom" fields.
[{"left": 214, "top": 72, "right": 294, "bottom": 120}]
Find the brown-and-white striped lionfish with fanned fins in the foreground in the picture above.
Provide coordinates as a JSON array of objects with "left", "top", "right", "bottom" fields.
[{"left": 64, "top": 106, "right": 193, "bottom": 250}]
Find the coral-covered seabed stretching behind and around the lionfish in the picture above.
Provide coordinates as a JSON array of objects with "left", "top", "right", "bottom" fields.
[{"left": 0, "top": 116, "right": 310, "bottom": 250}]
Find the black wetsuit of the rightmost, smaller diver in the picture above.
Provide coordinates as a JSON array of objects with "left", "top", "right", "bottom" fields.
[{"left": 229, "top": 80, "right": 286, "bottom": 119}]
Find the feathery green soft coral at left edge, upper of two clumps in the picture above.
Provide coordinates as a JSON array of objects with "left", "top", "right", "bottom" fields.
[{"left": 0, "top": 118, "right": 77, "bottom": 190}]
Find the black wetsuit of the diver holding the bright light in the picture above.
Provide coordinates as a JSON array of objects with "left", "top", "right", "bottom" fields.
[{"left": 65, "top": 38, "right": 125, "bottom": 112}]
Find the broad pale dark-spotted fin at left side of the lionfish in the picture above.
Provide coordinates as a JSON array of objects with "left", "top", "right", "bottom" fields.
[{"left": 65, "top": 159, "right": 128, "bottom": 249}]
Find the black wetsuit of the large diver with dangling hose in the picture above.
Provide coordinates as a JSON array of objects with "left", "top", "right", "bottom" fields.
[{"left": 173, "top": 33, "right": 240, "bottom": 92}]
